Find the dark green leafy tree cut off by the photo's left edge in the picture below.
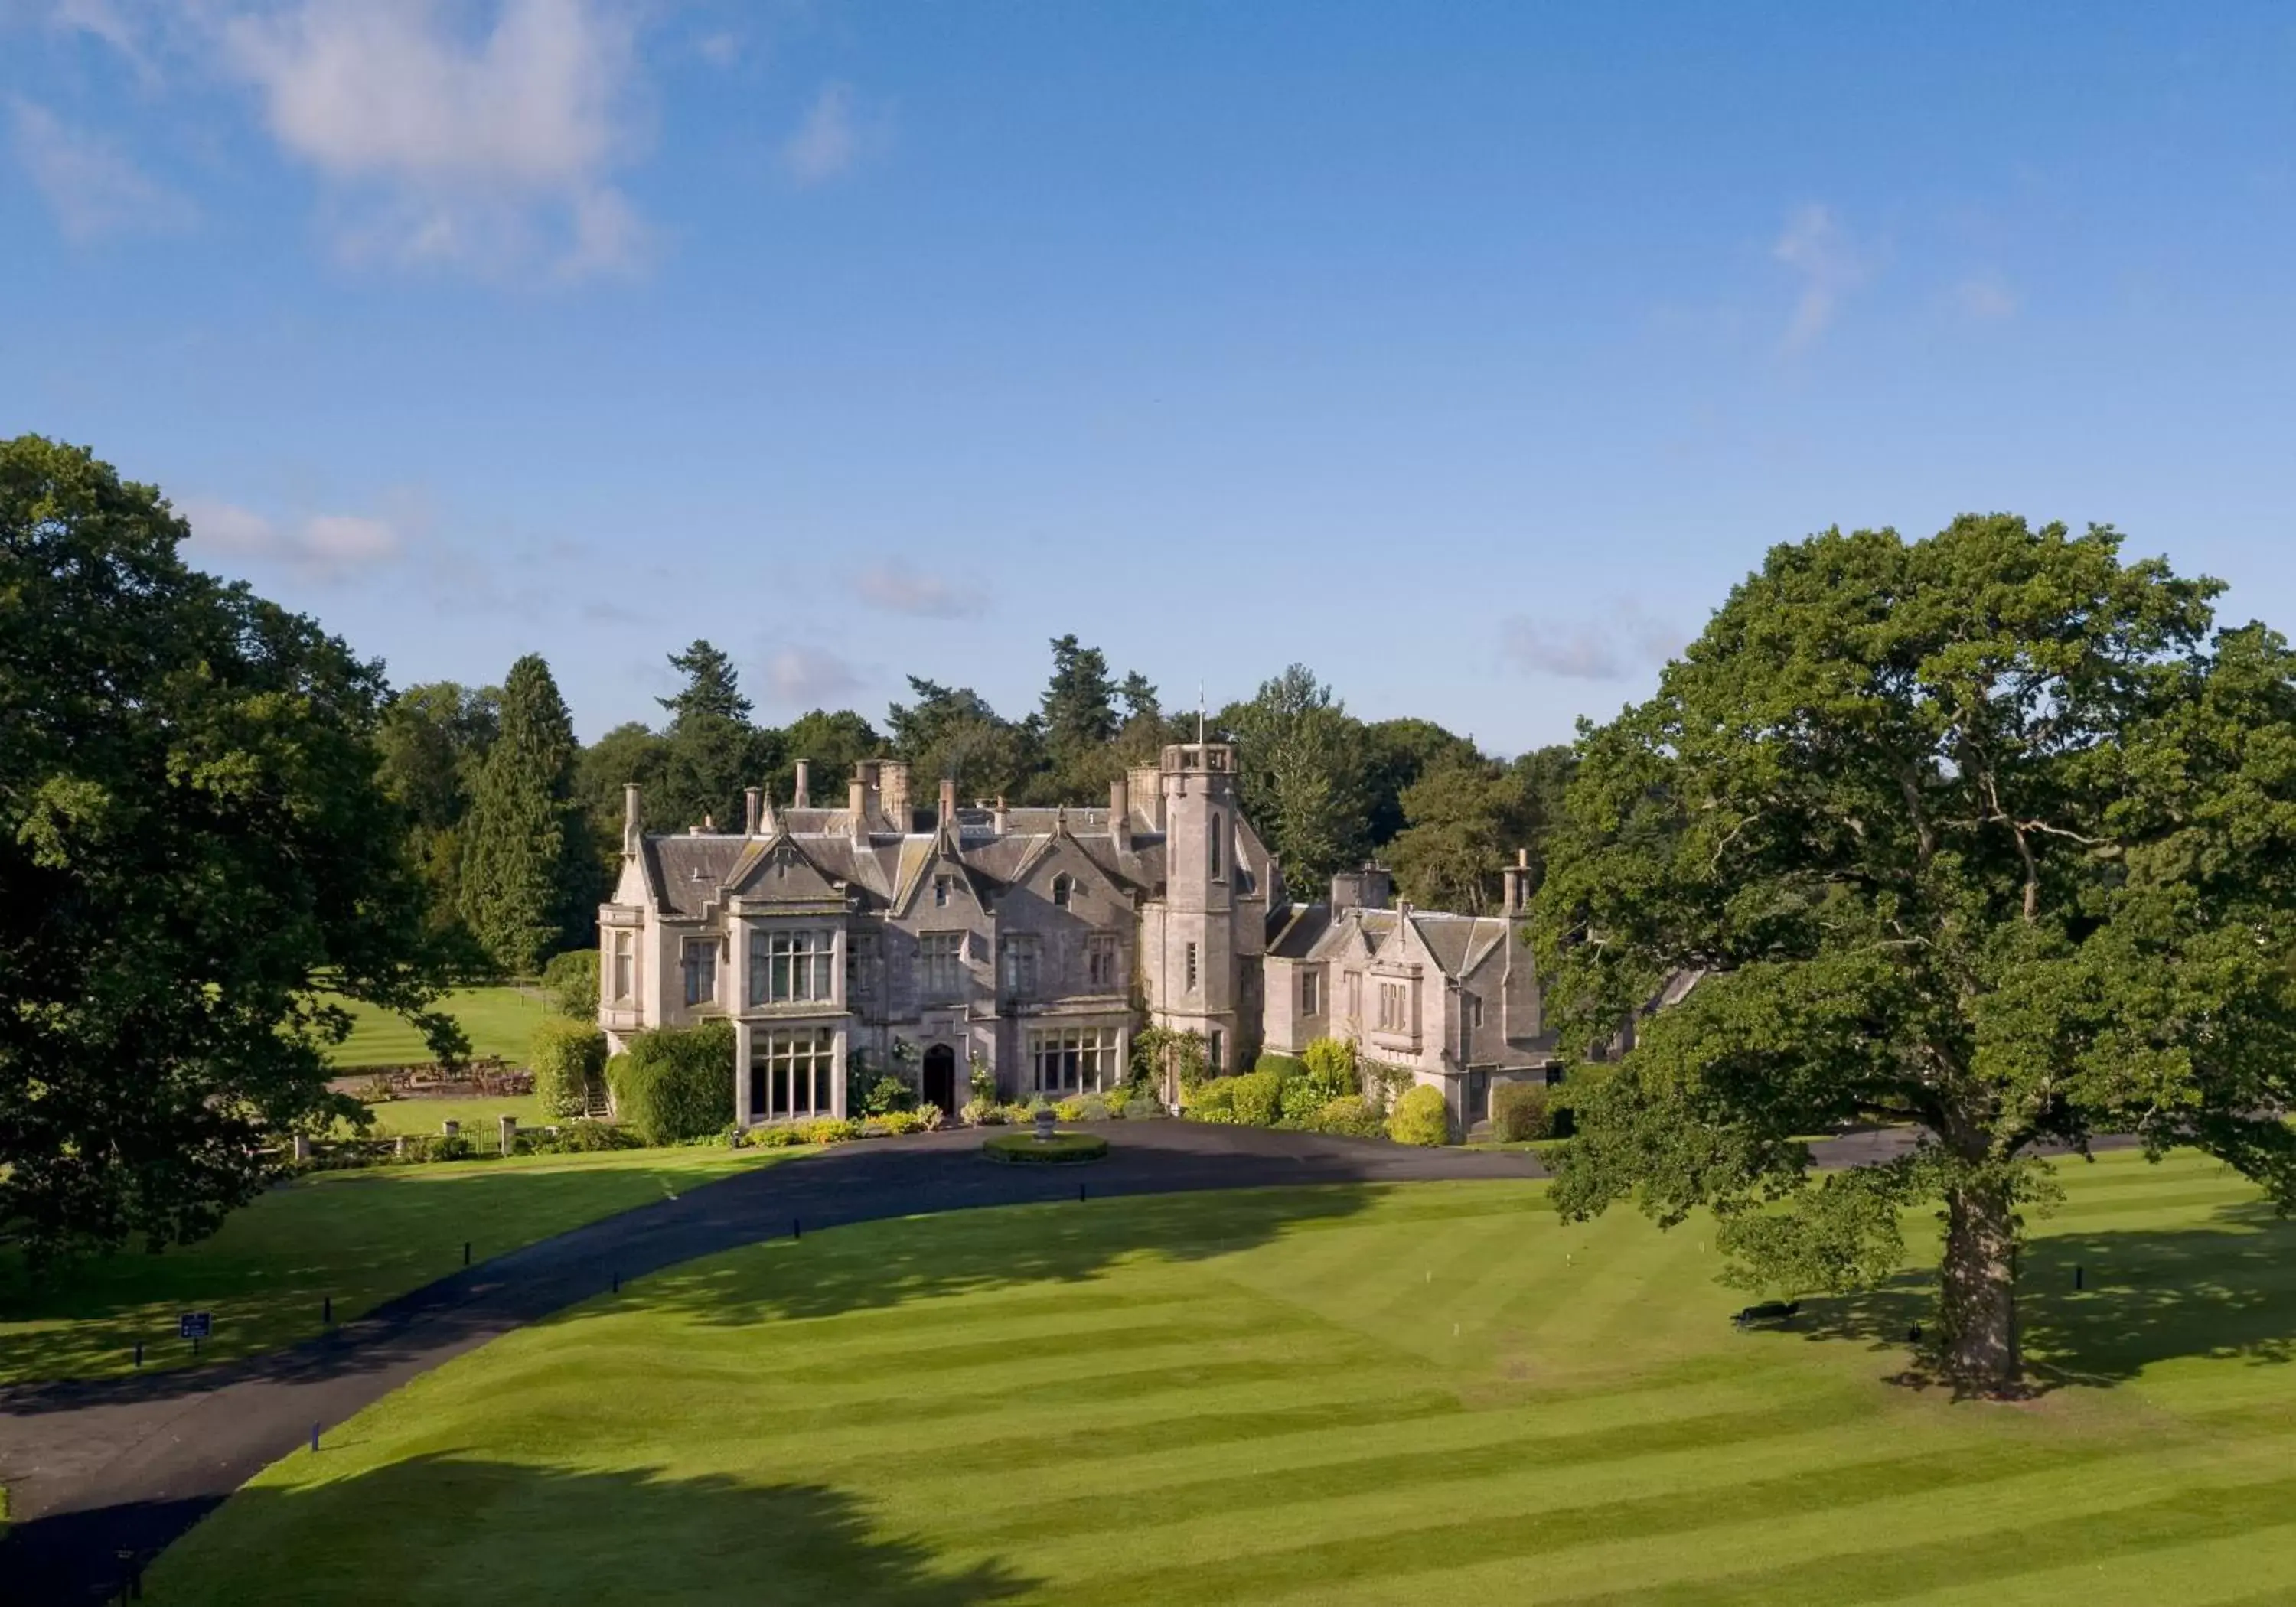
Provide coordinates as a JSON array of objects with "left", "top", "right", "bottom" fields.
[{"left": 0, "top": 436, "right": 464, "bottom": 1258}]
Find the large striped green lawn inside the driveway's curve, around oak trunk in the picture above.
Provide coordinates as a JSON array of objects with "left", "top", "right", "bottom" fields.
[{"left": 147, "top": 1155, "right": 2296, "bottom": 1607}]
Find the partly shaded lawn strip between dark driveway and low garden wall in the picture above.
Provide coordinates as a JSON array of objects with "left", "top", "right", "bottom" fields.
[{"left": 0, "top": 1148, "right": 804, "bottom": 1384}]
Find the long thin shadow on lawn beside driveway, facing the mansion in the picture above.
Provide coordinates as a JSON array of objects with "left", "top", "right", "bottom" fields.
[{"left": 629, "top": 1185, "right": 1384, "bottom": 1325}]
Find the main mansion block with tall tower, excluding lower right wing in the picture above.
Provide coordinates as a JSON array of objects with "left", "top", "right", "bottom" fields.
[{"left": 599, "top": 742, "right": 1281, "bottom": 1125}]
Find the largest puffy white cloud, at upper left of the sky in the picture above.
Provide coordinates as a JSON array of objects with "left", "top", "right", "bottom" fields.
[{"left": 223, "top": 0, "right": 647, "bottom": 275}]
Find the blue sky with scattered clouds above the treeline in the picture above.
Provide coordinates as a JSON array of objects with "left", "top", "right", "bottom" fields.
[{"left": 0, "top": 0, "right": 2296, "bottom": 751}]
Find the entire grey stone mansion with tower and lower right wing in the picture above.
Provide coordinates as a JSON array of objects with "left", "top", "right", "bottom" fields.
[{"left": 599, "top": 742, "right": 1589, "bottom": 1127}]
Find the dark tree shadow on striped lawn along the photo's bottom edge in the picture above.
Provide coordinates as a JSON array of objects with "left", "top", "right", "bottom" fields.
[{"left": 20, "top": 1453, "right": 1035, "bottom": 1607}]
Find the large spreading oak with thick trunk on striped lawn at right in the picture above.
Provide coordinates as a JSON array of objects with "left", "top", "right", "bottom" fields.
[{"left": 1534, "top": 517, "right": 2296, "bottom": 1393}]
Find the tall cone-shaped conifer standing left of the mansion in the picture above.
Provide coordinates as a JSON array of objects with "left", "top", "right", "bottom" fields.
[{"left": 461, "top": 654, "right": 597, "bottom": 976}]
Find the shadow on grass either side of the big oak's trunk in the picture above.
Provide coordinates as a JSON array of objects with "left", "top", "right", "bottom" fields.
[{"left": 1793, "top": 1203, "right": 2296, "bottom": 1389}]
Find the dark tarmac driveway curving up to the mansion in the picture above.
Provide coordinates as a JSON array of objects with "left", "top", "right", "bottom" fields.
[{"left": 0, "top": 1120, "right": 1543, "bottom": 1602}]
